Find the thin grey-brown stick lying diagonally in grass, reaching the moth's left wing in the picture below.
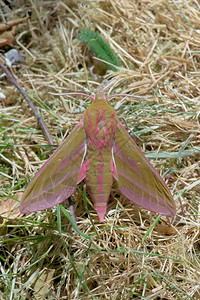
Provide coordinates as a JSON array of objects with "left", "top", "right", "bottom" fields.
[{"left": 0, "top": 61, "right": 53, "bottom": 145}]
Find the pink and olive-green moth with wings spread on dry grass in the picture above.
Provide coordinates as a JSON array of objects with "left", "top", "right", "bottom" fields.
[{"left": 20, "top": 93, "right": 176, "bottom": 222}]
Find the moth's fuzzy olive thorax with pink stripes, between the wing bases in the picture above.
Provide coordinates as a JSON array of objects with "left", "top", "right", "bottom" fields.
[{"left": 84, "top": 97, "right": 117, "bottom": 151}]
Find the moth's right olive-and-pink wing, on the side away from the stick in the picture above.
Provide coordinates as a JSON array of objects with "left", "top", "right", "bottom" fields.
[{"left": 113, "top": 121, "right": 176, "bottom": 217}]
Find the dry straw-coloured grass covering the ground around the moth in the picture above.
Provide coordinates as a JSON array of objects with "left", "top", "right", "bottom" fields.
[{"left": 0, "top": 0, "right": 200, "bottom": 299}]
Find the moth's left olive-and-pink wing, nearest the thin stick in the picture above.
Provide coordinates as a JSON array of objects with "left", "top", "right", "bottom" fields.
[{"left": 20, "top": 121, "right": 86, "bottom": 214}]
